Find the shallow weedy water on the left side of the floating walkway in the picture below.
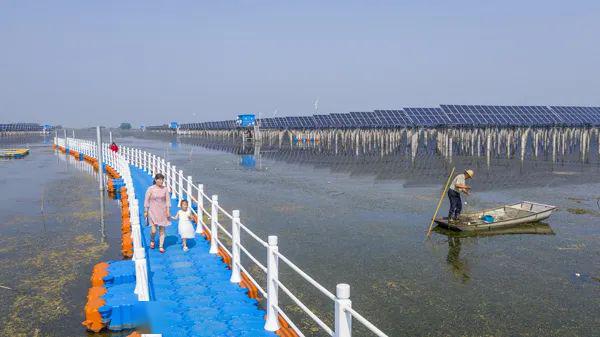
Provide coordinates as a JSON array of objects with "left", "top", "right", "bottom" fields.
[{"left": 0, "top": 137, "right": 126, "bottom": 337}]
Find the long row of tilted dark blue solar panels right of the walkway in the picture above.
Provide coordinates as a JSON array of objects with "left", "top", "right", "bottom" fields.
[{"left": 175, "top": 105, "right": 600, "bottom": 130}]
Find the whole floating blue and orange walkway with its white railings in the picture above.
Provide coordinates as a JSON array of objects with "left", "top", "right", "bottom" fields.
[{"left": 54, "top": 138, "right": 387, "bottom": 337}]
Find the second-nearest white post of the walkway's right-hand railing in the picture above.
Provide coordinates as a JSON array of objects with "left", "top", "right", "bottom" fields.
[{"left": 265, "top": 235, "right": 279, "bottom": 331}]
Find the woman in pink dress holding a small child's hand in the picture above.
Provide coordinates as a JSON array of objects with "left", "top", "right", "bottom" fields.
[{"left": 144, "top": 173, "right": 171, "bottom": 253}]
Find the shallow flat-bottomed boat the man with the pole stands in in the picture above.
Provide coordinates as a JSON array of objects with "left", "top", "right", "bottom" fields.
[{"left": 435, "top": 201, "right": 556, "bottom": 231}]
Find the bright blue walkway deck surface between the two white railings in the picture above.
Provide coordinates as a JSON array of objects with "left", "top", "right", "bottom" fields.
[{"left": 131, "top": 166, "right": 276, "bottom": 337}]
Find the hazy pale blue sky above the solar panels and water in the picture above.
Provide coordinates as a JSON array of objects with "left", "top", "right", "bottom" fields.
[{"left": 0, "top": 0, "right": 600, "bottom": 126}]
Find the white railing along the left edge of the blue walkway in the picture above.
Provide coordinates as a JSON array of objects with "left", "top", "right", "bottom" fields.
[{"left": 54, "top": 137, "right": 150, "bottom": 301}]
